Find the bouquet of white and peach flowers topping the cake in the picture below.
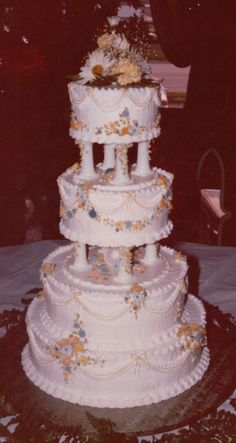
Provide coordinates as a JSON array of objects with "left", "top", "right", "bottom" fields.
[{"left": 78, "top": 17, "right": 156, "bottom": 86}]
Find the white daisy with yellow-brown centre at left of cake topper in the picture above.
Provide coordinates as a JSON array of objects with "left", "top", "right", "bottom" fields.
[{"left": 79, "top": 49, "right": 112, "bottom": 85}]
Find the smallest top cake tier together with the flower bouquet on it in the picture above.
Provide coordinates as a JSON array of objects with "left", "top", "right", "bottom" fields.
[{"left": 68, "top": 17, "right": 161, "bottom": 144}]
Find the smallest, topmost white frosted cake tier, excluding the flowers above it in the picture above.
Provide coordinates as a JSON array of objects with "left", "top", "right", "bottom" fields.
[{"left": 68, "top": 82, "right": 160, "bottom": 143}]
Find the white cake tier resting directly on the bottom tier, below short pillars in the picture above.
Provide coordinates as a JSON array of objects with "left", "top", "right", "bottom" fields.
[{"left": 37, "top": 245, "right": 187, "bottom": 349}]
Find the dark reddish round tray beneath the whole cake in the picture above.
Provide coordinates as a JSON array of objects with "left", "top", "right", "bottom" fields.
[{"left": 0, "top": 294, "right": 236, "bottom": 443}]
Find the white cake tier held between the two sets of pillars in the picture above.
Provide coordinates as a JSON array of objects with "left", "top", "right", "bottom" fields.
[{"left": 58, "top": 168, "right": 173, "bottom": 247}]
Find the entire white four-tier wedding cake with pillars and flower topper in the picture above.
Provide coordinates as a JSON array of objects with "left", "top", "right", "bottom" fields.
[{"left": 22, "top": 18, "right": 209, "bottom": 408}]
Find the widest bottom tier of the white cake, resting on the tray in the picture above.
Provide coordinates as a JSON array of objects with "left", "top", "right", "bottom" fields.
[{"left": 22, "top": 295, "right": 209, "bottom": 408}]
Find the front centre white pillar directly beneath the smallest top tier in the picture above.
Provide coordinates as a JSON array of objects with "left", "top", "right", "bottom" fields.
[{"left": 112, "top": 144, "right": 130, "bottom": 185}]
